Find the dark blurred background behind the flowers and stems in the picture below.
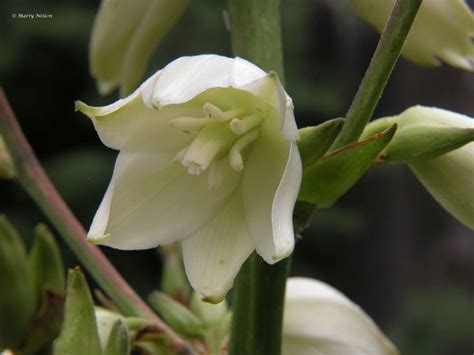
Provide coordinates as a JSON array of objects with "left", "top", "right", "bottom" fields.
[{"left": 0, "top": 0, "right": 474, "bottom": 355}]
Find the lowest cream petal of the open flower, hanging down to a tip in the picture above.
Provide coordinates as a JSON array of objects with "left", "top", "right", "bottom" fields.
[{"left": 183, "top": 188, "right": 255, "bottom": 303}]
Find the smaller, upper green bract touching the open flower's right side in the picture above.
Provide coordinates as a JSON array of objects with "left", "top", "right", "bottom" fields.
[{"left": 298, "top": 118, "right": 344, "bottom": 166}]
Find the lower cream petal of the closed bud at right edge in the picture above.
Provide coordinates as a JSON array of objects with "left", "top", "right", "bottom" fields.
[{"left": 410, "top": 143, "right": 474, "bottom": 230}]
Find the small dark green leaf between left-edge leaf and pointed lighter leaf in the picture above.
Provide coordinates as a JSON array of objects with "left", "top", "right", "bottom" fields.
[{"left": 28, "top": 224, "right": 65, "bottom": 302}]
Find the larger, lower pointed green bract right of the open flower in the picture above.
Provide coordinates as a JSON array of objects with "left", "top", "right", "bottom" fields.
[{"left": 298, "top": 125, "right": 397, "bottom": 207}]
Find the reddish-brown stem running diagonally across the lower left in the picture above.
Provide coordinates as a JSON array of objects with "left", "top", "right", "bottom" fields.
[{"left": 0, "top": 88, "right": 188, "bottom": 354}]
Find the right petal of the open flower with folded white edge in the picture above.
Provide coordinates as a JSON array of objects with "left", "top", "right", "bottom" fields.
[{"left": 243, "top": 117, "right": 302, "bottom": 264}]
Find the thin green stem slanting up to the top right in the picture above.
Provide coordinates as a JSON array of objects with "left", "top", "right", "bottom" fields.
[{"left": 331, "top": 0, "right": 423, "bottom": 150}]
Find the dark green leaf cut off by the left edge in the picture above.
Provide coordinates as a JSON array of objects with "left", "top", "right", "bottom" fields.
[{"left": 0, "top": 215, "right": 35, "bottom": 349}]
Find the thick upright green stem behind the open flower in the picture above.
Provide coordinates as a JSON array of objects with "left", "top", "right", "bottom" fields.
[{"left": 228, "top": 0, "right": 290, "bottom": 355}]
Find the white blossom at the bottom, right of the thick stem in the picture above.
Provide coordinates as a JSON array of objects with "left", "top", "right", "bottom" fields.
[{"left": 282, "top": 278, "right": 398, "bottom": 355}]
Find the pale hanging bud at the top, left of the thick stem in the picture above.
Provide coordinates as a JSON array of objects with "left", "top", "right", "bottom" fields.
[{"left": 89, "top": 0, "right": 189, "bottom": 96}]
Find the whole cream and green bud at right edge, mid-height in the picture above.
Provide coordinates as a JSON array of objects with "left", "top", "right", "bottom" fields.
[{"left": 364, "top": 106, "right": 474, "bottom": 229}]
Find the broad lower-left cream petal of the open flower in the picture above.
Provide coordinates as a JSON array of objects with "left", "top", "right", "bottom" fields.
[{"left": 88, "top": 151, "right": 239, "bottom": 249}]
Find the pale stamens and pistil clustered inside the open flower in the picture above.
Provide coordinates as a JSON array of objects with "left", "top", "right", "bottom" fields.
[{"left": 169, "top": 103, "right": 263, "bottom": 178}]
